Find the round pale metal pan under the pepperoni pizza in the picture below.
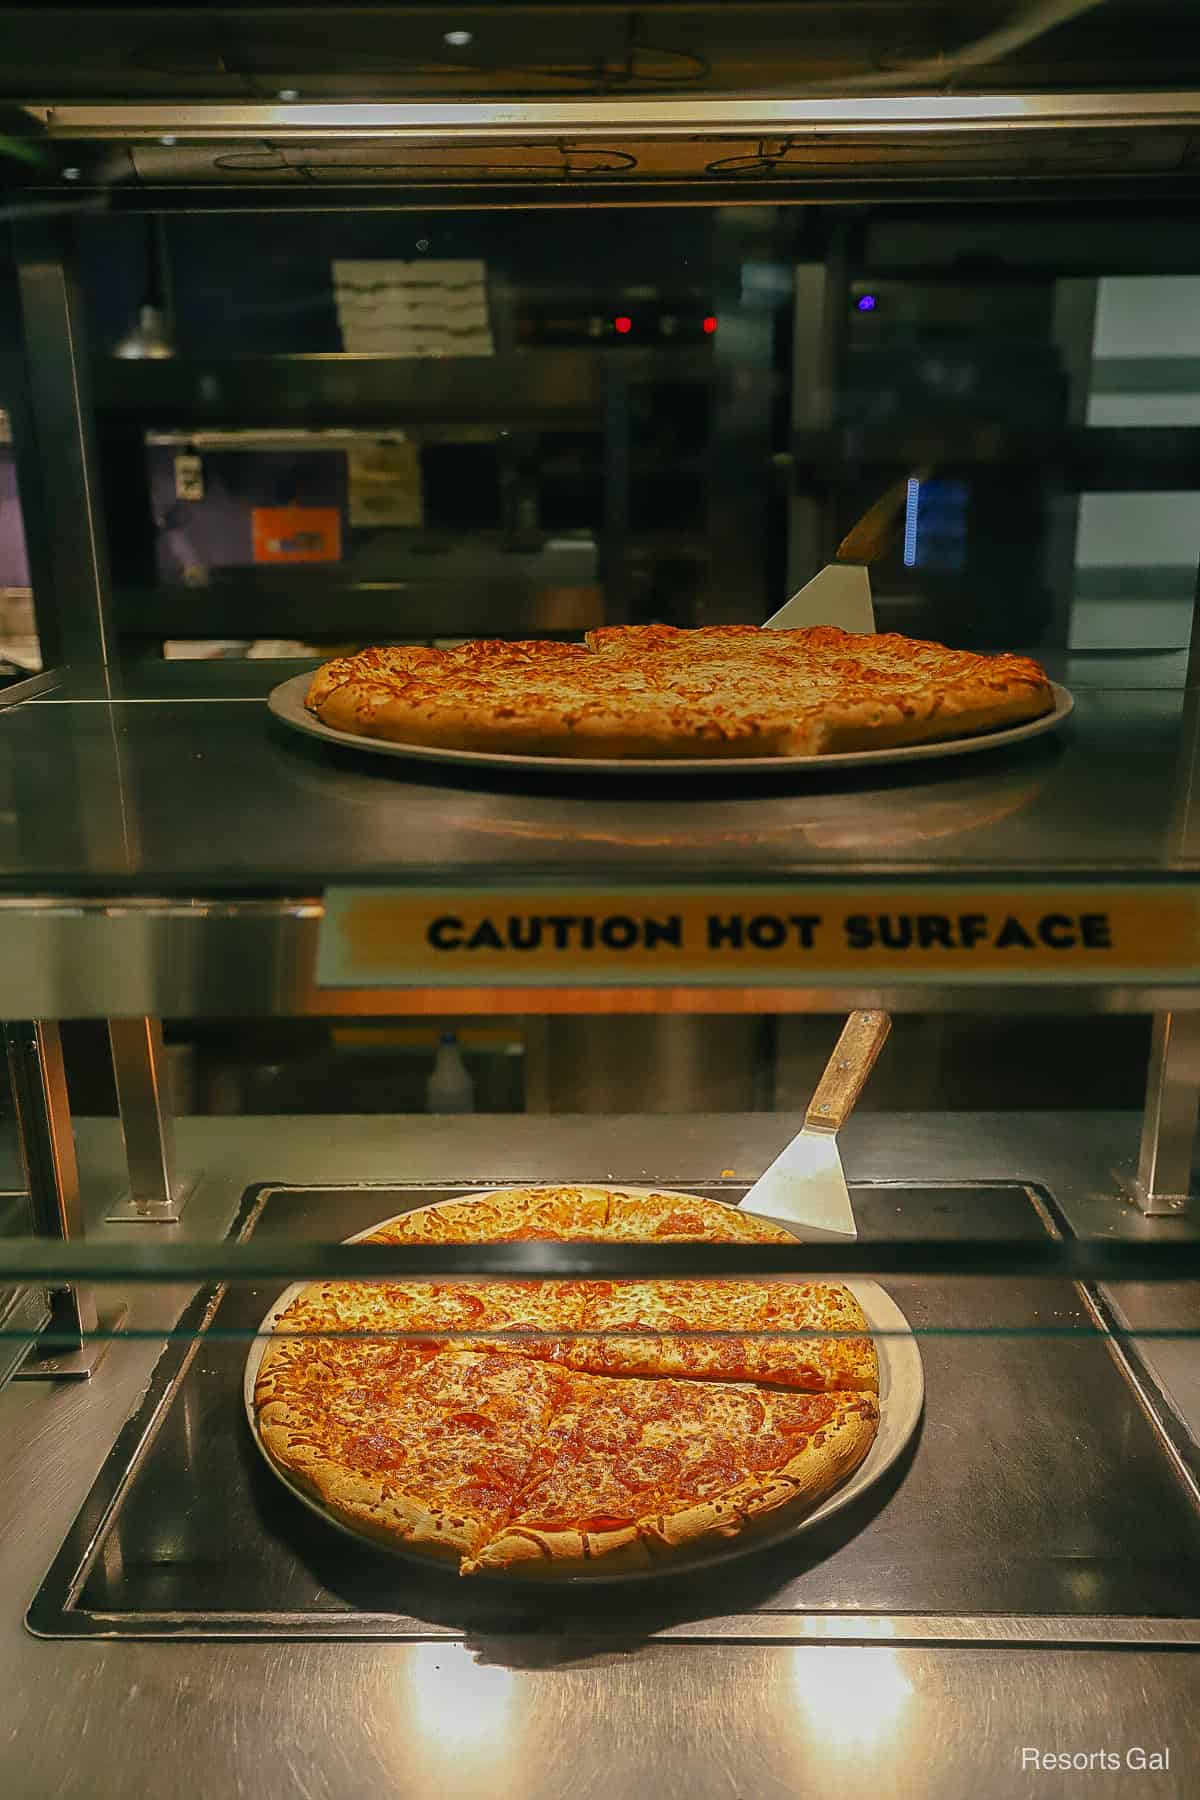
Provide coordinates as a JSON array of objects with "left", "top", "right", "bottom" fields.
[{"left": 241, "top": 1183, "right": 925, "bottom": 1589}]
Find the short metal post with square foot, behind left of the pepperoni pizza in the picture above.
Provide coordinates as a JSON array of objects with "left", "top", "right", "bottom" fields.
[{"left": 108, "top": 1019, "right": 196, "bottom": 1224}]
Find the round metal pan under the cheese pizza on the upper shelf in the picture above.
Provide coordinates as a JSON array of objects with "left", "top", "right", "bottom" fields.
[{"left": 266, "top": 673, "right": 1074, "bottom": 779}]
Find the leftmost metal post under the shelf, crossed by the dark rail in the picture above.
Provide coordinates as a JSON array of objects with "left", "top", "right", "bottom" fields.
[{"left": 4, "top": 1021, "right": 126, "bottom": 1381}]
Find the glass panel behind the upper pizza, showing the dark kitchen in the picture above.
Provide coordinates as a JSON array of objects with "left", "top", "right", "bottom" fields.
[{"left": 39, "top": 205, "right": 1200, "bottom": 679}]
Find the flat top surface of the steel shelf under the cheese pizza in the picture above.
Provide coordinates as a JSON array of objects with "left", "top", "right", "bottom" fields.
[{"left": 0, "top": 659, "right": 1200, "bottom": 898}]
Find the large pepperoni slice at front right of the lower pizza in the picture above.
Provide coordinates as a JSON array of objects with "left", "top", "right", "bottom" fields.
[{"left": 462, "top": 1377, "right": 878, "bottom": 1575}]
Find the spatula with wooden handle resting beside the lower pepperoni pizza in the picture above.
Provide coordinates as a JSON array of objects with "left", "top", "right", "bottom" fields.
[{"left": 741, "top": 1012, "right": 892, "bottom": 1237}]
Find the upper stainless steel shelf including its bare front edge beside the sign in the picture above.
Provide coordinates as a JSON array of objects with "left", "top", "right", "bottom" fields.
[{"left": 0, "top": 659, "right": 1200, "bottom": 1017}]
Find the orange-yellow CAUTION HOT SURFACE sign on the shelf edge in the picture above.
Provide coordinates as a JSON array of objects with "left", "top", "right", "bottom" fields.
[{"left": 317, "top": 884, "right": 1200, "bottom": 986}]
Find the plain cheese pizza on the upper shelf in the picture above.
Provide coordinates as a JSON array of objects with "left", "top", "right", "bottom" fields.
[{"left": 306, "top": 625, "right": 1054, "bottom": 758}]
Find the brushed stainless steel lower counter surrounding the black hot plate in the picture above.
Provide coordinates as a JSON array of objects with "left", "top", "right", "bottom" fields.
[{"left": 0, "top": 1114, "right": 1200, "bottom": 1800}]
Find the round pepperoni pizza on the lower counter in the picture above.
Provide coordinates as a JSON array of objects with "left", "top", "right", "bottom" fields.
[{"left": 254, "top": 1186, "right": 880, "bottom": 1575}]
